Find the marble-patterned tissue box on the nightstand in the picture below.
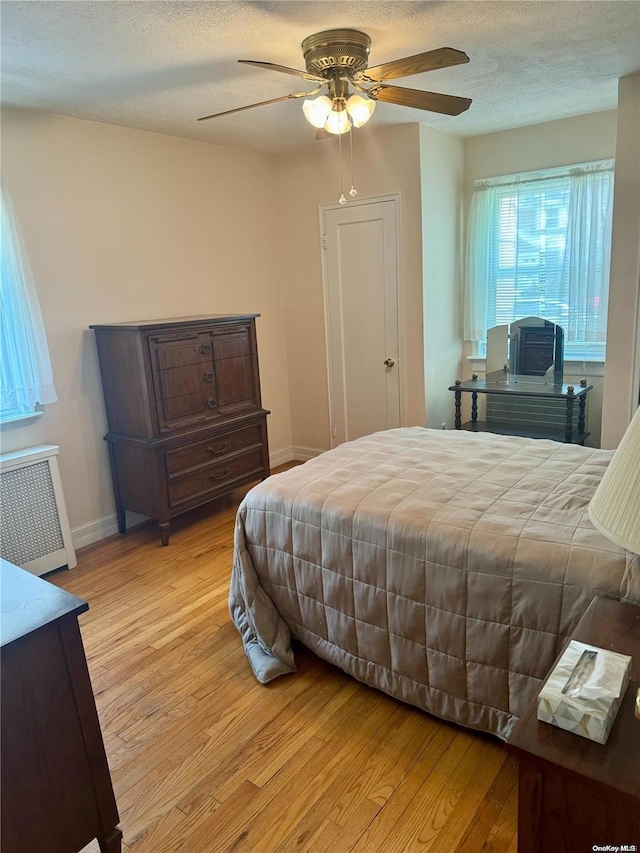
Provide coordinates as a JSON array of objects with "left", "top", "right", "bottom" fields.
[{"left": 538, "top": 640, "right": 631, "bottom": 743}]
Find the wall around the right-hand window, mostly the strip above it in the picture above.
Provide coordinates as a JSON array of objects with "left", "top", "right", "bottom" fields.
[{"left": 460, "top": 110, "right": 617, "bottom": 446}]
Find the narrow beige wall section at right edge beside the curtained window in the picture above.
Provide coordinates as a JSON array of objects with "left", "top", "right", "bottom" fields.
[{"left": 602, "top": 71, "right": 640, "bottom": 447}]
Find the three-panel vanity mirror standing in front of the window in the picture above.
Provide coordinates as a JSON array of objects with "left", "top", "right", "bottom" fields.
[{"left": 486, "top": 317, "right": 564, "bottom": 386}]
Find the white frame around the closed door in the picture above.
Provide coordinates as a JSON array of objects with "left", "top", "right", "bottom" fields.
[{"left": 318, "top": 193, "right": 405, "bottom": 449}]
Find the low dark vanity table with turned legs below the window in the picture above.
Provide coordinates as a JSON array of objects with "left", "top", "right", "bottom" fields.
[{"left": 449, "top": 376, "right": 593, "bottom": 444}]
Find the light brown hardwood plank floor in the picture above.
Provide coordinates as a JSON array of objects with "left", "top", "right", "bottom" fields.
[{"left": 48, "top": 476, "right": 517, "bottom": 853}]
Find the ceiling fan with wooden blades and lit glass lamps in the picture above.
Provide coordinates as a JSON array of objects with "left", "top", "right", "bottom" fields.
[{"left": 198, "top": 29, "right": 471, "bottom": 134}]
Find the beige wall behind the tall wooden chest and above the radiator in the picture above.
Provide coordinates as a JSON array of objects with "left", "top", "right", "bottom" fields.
[{"left": 2, "top": 110, "right": 291, "bottom": 544}]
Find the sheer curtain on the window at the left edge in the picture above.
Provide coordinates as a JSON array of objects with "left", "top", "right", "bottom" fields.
[{"left": 0, "top": 180, "right": 57, "bottom": 420}]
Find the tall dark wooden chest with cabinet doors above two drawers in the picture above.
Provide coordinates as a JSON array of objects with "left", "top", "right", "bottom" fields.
[{"left": 91, "top": 314, "right": 269, "bottom": 545}]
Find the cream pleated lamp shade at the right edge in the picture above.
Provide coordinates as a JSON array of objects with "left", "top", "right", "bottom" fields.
[{"left": 589, "top": 408, "right": 640, "bottom": 554}]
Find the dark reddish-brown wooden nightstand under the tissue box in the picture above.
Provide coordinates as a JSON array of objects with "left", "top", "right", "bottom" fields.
[{"left": 507, "top": 598, "right": 640, "bottom": 853}]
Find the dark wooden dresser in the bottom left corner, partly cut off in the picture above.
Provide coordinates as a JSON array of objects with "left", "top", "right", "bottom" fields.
[{"left": 0, "top": 560, "right": 122, "bottom": 853}]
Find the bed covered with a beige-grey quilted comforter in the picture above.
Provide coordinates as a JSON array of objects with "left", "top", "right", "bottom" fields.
[{"left": 229, "top": 427, "right": 640, "bottom": 738}]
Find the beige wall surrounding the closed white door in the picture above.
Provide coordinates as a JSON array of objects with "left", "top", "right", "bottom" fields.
[{"left": 276, "top": 125, "right": 424, "bottom": 455}]
